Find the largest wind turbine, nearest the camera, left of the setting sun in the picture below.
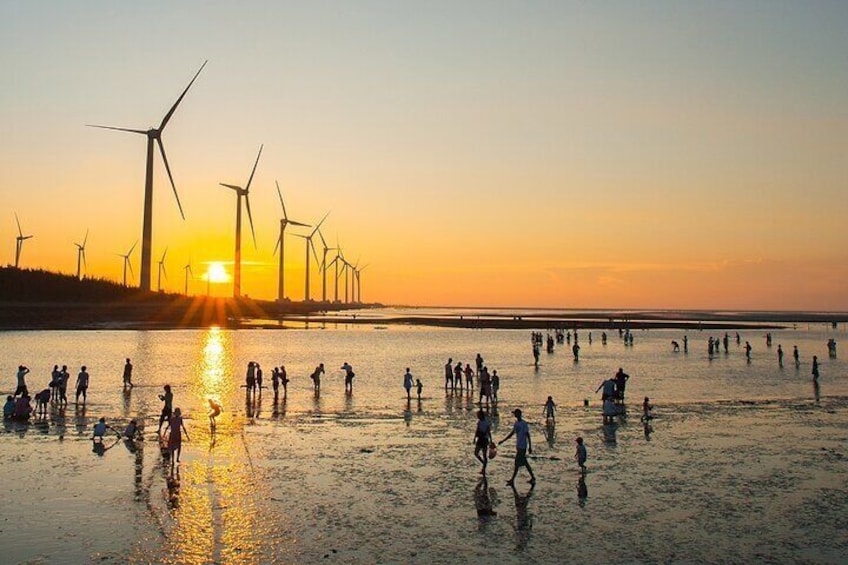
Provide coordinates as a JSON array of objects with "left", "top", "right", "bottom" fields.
[{"left": 89, "top": 61, "right": 208, "bottom": 291}]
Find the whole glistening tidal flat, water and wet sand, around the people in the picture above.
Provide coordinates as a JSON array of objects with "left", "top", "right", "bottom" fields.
[{"left": 0, "top": 326, "right": 848, "bottom": 563}]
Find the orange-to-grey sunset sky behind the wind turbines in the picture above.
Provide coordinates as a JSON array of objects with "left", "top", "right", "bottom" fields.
[{"left": 0, "top": 0, "right": 848, "bottom": 311}]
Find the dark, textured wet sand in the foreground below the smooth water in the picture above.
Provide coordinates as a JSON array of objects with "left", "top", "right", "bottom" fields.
[{"left": 0, "top": 394, "right": 848, "bottom": 563}]
